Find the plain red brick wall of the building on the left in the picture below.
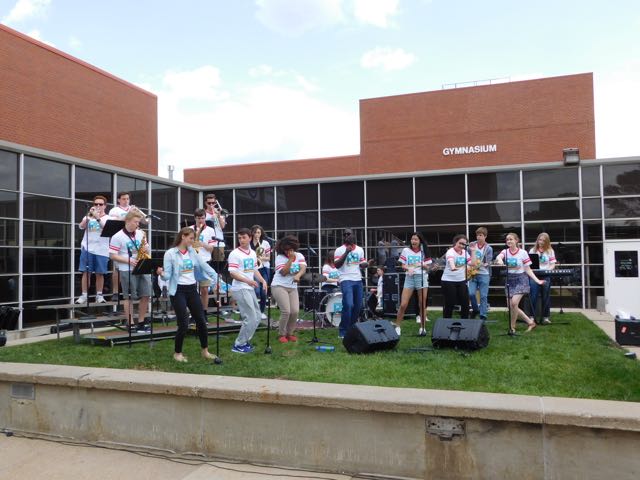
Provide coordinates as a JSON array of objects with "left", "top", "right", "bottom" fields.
[{"left": 0, "top": 25, "right": 158, "bottom": 175}]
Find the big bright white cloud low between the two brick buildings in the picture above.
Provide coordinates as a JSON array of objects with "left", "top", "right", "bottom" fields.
[{"left": 153, "top": 66, "right": 359, "bottom": 181}]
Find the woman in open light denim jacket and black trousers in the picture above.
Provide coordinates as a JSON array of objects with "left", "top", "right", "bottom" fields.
[{"left": 156, "top": 227, "right": 218, "bottom": 362}]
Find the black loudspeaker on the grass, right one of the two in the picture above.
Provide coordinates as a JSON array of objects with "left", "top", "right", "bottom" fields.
[{"left": 431, "top": 318, "right": 489, "bottom": 350}]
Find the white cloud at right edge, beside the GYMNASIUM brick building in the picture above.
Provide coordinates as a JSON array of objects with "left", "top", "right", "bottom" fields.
[{"left": 594, "top": 60, "right": 640, "bottom": 158}]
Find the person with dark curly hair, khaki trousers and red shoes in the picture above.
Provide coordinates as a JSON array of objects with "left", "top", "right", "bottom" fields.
[{"left": 271, "top": 235, "right": 307, "bottom": 343}]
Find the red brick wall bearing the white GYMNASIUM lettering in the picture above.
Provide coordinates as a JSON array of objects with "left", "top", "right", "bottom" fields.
[{"left": 184, "top": 73, "right": 596, "bottom": 185}]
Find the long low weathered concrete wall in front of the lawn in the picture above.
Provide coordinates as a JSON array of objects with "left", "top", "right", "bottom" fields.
[{"left": 0, "top": 363, "right": 640, "bottom": 479}]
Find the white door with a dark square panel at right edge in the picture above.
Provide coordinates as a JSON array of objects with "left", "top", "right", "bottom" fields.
[{"left": 604, "top": 240, "right": 640, "bottom": 318}]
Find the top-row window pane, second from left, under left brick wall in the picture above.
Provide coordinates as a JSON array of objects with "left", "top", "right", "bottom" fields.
[{"left": 24, "top": 156, "right": 71, "bottom": 197}]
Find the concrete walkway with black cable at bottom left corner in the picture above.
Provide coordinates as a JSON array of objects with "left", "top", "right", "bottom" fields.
[{"left": 0, "top": 435, "right": 353, "bottom": 480}]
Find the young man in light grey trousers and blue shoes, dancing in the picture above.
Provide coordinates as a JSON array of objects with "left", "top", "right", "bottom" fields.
[{"left": 229, "top": 228, "right": 267, "bottom": 353}]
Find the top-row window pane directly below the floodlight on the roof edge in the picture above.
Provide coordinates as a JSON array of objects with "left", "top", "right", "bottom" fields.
[{"left": 522, "top": 167, "right": 578, "bottom": 198}]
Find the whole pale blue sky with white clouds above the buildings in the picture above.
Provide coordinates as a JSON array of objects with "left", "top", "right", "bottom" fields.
[{"left": 0, "top": 0, "right": 640, "bottom": 179}]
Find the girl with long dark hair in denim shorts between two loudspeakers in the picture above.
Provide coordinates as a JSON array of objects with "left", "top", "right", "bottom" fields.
[{"left": 395, "top": 232, "right": 433, "bottom": 337}]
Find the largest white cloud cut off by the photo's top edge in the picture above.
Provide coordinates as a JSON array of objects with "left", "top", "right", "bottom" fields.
[{"left": 256, "top": 0, "right": 345, "bottom": 36}]
